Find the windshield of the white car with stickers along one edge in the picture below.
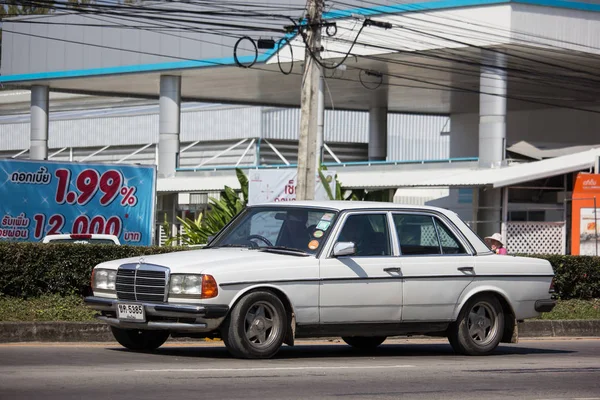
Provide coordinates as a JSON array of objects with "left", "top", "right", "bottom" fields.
[{"left": 210, "top": 207, "right": 337, "bottom": 254}]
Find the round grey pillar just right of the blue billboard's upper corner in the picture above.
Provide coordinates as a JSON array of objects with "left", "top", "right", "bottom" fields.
[{"left": 158, "top": 75, "right": 181, "bottom": 178}]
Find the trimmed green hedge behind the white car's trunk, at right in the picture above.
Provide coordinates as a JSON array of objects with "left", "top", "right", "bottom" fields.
[{"left": 529, "top": 255, "right": 600, "bottom": 300}]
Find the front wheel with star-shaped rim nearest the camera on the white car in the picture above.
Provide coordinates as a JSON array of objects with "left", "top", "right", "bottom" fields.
[{"left": 221, "top": 291, "right": 287, "bottom": 358}]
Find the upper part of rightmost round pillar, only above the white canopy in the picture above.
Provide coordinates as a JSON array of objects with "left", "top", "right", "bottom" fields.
[{"left": 479, "top": 53, "right": 507, "bottom": 168}]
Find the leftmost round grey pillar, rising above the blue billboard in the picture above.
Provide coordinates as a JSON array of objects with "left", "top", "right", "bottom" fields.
[{"left": 29, "top": 86, "right": 50, "bottom": 160}]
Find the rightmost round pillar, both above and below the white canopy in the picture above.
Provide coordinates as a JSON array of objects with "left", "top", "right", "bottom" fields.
[{"left": 477, "top": 52, "right": 507, "bottom": 236}]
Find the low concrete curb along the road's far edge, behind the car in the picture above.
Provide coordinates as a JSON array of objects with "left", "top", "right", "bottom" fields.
[{"left": 0, "top": 320, "right": 600, "bottom": 343}]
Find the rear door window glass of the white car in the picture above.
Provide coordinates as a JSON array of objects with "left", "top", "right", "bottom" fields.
[{"left": 394, "top": 214, "right": 466, "bottom": 256}]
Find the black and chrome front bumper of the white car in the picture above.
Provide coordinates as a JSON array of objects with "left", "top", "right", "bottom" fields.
[{"left": 84, "top": 296, "right": 229, "bottom": 333}]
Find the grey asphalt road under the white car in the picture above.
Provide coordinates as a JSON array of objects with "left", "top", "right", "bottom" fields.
[{"left": 0, "top": 339, "right": 600, "bottom": 400}]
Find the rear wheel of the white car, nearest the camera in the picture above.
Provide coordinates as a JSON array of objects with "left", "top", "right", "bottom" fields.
[{"left": 448, "top": 294, "right": 504, "bottom": 356}]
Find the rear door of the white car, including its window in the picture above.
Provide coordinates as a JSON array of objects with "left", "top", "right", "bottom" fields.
[{"left": 393, "top": 213, "right": 475, "bottom": 322}]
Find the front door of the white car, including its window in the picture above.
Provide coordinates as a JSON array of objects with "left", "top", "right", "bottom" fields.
[{"left": 319, "top": 212, "right": 402, "bottom": 324}]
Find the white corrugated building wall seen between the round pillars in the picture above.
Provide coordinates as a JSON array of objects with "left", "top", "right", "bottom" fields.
[{"left": 0, "top": 104, "right": 450, "bottom": 161}]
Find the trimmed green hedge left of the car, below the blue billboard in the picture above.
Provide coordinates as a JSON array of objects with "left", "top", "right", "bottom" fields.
[{"left": 0, "top": 242, "right": 184, "bottom": 298}]
